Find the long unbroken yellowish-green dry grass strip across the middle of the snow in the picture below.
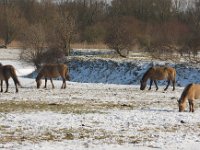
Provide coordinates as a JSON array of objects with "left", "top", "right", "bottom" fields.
[{"left": 0, "top": 101, "right": 141, "bottom": 114}]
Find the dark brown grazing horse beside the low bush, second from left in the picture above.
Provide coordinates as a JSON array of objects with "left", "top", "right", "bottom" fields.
[{"left": 36, "top": 64, "right": 69, "bottom": 89}]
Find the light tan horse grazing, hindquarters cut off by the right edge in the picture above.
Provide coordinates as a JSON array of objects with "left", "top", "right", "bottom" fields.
[{"left": 178, "top": 83, "right": 200, "bottom": 112}]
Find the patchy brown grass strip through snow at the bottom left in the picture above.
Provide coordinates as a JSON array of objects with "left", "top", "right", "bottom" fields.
[{"left": 0, "top": 127, "right": 115, "bottom": 144}]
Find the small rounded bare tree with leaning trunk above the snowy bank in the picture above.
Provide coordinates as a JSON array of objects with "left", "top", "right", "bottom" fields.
[{"left": 105, "top": 19, "right": 133, "bottom": 57}]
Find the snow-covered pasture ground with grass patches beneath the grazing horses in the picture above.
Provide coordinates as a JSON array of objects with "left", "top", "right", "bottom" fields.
[{"left": 0, "top": 49, "right": 200, "bottom": 150}]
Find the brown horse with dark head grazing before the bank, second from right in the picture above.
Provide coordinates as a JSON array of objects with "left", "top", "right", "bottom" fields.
[{"left": 140, "top": 67, "right": 176, "bottom": 91}]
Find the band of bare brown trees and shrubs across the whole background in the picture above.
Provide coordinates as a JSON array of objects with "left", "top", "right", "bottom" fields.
[{"left": 0, "top": 0, "right": 200, "bottom": 67}]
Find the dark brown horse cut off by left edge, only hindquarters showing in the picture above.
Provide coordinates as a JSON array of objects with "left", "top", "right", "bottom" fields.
[{"left": 0, "top": 63, "right": 21, "bottom": 93}]
